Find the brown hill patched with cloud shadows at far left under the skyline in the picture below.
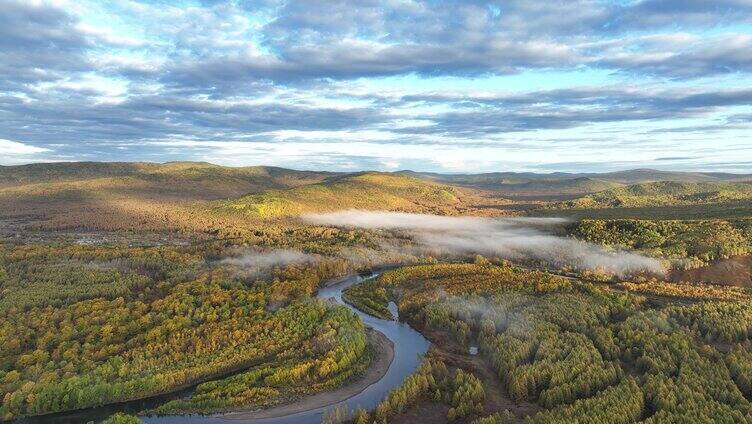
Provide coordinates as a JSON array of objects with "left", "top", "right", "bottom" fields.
[{"left": 0, "top": 162, "right": 336, "bottom": 232}]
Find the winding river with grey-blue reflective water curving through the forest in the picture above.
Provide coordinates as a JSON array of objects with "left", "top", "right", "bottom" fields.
[{"left": 18, "top": 274, "right": 429, "bottom": 424}]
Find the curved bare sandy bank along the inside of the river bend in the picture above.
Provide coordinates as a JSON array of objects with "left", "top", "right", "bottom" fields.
[{"left": 221, "top": 328, "right": 394, "bottom": 420}]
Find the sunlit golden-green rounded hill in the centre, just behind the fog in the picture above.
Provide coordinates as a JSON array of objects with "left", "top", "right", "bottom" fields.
[{"left": 225, "top": 172, "right": 482, "bottom": 218}]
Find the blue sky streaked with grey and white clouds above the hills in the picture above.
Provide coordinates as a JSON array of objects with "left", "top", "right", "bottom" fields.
[{"left": 0, "top": 0, "right": 752, "bottom": 173}]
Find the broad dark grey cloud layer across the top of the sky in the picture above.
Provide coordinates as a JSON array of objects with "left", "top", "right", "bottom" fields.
[{"left": 5, "top": 0, "right": 752, "bottom": 88}]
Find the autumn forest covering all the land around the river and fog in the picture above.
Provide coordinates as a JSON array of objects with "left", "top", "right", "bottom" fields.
[{"left": 0, "top": 163, "right": 752, "bottom": 424}]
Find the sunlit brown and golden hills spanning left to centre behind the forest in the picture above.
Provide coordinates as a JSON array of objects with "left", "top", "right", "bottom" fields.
[{"left": 0, "top": 162, "right": 505, "bottom": 237}]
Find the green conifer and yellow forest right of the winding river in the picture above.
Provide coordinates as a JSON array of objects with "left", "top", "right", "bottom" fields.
[{"left": 340, "top": 262, "right": 752, "bottom": 423}]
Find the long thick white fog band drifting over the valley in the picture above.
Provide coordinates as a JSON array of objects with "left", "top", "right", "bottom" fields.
[{"left": 304, "top": 210, "right": 665, "bottom": 276}]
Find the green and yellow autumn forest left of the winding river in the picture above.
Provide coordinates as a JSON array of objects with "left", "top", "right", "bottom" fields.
[{"left": 0, "top": 240, "right": 369, "bottom": 420}]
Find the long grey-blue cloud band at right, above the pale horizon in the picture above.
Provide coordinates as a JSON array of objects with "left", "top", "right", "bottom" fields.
[{"left": 395, "top": 87, "right": 752, "bottom": 138}]
